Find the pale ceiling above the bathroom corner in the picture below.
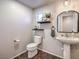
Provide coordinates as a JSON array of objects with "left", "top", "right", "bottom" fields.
[{"left": 17, "top": 0, "right": 55, "bottom": 8}]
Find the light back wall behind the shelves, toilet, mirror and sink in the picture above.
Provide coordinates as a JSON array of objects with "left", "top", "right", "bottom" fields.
[{"left": 34, "top": 0, "right": 79, "bottom": 59}]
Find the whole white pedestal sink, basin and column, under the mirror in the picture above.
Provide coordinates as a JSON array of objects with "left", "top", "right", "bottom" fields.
[{"left": 56, "top": 36, "right": 79, "bottom": 59}]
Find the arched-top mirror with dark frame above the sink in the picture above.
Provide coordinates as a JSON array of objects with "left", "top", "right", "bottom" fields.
[{"left": 57, "top": 11, "right": 79, "bottom": 33}]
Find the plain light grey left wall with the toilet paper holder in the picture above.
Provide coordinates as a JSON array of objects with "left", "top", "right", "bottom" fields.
[{"left": 0, "top": 0, "right": 32, "bottom": 59}]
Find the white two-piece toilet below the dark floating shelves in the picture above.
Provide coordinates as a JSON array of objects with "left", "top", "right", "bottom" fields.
[{"left": 26, "top": 36, "right": 42, "bottom": 58}]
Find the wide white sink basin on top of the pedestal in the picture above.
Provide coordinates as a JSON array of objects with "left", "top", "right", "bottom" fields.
[{"left": 56, "top": 36, "right": 79, "bottom": 44}]
